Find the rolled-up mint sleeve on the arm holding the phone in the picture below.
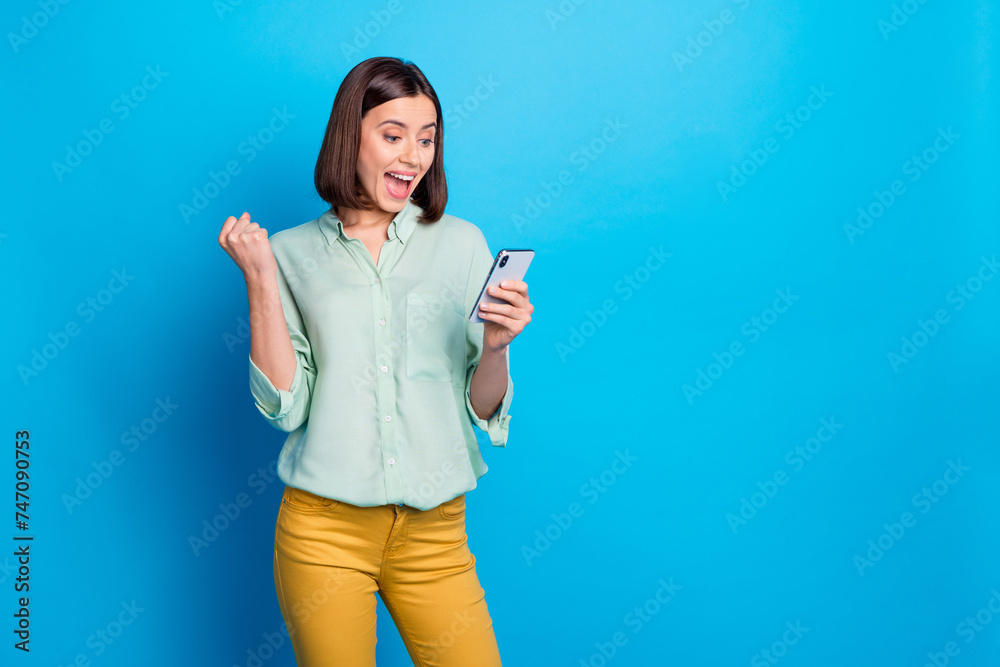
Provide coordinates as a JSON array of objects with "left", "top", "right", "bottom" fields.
[{"left": 465, "top": 229, "right": 514, "bottom": 447}]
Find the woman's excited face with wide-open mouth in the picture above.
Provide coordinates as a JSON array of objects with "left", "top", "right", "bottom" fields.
[{"left": 357, "top": 95, "right": 438, "bottom": 213}]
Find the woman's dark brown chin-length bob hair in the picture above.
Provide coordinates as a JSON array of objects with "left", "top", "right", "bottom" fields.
[{"left": 313, "top": 56, "right": 448, "bottom": 222}]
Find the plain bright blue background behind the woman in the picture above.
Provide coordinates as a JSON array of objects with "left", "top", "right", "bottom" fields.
[{"left": 0, "top": 0, "right": 1000, "bottom": 667}]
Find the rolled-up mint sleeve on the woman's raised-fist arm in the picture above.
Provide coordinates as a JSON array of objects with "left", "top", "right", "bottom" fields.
[{"left": 248, "top": 255, "right": 316, "bottom": 432}]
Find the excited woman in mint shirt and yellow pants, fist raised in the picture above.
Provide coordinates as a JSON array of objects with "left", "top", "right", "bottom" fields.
[{"left": 219, "top": 58, "right": 534, "bottom": 667}]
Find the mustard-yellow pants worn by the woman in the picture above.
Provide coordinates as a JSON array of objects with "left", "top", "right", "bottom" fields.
[{"left": 274, "top": 486, "right": 500, "bottom": 667}]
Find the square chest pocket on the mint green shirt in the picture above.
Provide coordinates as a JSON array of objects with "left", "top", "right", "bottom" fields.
[{"left": 406, "top": 292, "right": 465, "bottom": 387}]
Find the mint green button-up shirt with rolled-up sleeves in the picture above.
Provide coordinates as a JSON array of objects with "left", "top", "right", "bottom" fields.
[{"left": 250, "top": 201, "right": 514, "bottom": 510}]
